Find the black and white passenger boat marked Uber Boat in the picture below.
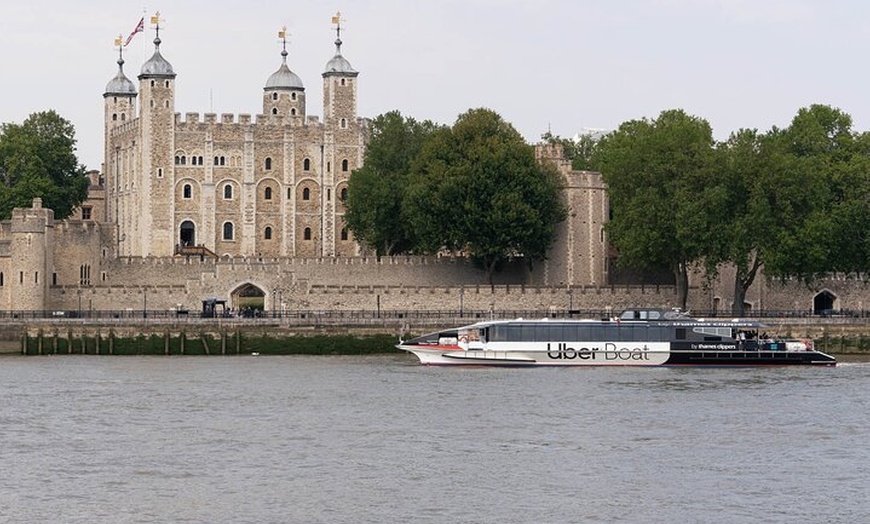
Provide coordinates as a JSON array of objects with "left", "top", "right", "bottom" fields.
[{"left": 396, "top": 309, "right": 837, "bottom": 366}]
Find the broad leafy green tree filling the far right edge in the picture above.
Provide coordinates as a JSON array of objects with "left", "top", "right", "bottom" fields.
[{"left": 707, "top": 105, "right": 868, "bottom": 316}]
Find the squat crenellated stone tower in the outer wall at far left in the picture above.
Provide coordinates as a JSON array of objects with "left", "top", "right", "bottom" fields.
[{"left": 9, "top": 198, "right": 54, "bottom": 311}]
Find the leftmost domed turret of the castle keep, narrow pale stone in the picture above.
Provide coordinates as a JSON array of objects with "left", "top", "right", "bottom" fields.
[{"left": 103, "top": 36, "right": 136, "bottom": 223}]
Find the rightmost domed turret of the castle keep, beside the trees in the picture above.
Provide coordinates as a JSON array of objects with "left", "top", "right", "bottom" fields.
[{"left": 321, "top": 12, "right": 364, "bottom": 256}]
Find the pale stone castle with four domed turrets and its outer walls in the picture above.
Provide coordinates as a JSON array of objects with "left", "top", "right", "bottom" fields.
[{"left": 0, "top": 15, "right": 867, "bottom": 313}]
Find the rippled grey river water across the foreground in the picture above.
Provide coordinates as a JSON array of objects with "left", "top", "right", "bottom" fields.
[{"left": 0, "top": 355, "right": 870, "bottom": 524}]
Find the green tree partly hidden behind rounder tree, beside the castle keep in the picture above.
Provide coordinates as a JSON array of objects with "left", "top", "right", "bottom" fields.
[{"left": 344, "top": 111, "right": 438, "bottom": 256}]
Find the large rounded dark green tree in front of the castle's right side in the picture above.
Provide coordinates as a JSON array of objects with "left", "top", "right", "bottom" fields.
[{"left": 403, "top": 109, "right": 567, "bottom": 283}]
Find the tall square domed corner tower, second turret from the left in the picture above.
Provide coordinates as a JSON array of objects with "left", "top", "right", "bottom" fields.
[{"left": 135, "top": 15, "right": 175, "bottom": 256}]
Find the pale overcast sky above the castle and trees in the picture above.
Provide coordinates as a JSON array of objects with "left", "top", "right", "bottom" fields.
[{"left": 0, "top": 0, "right": 870, "bottom": 169}]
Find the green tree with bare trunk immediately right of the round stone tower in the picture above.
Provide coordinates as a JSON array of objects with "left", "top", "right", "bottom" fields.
[{"left": 594, "top": 109, "right": 721, "bottom": 308}]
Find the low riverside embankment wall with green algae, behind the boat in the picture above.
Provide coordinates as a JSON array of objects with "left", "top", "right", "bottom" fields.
[{"left": 0, "top": 312, "right": 870, "bottom": 354}]
